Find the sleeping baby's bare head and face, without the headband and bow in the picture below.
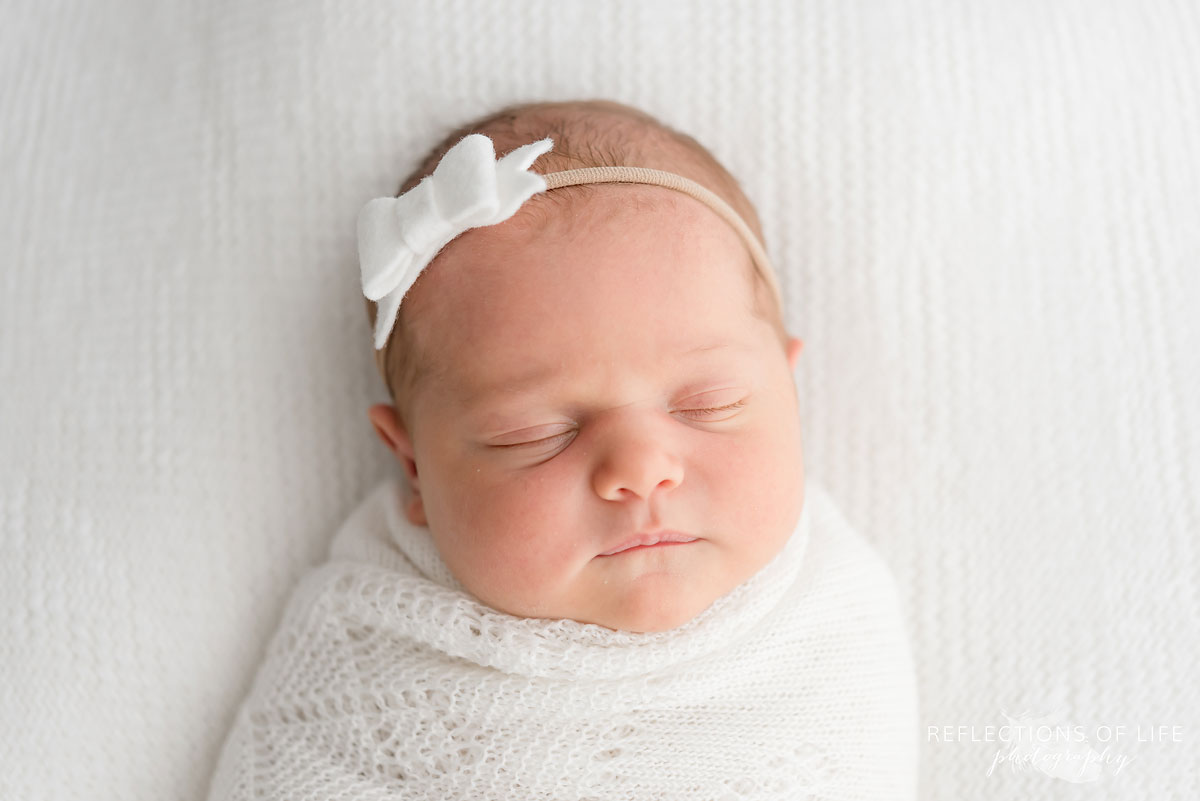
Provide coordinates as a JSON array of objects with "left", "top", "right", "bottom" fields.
[{"left": 367, "top": 102, "right": 804, "bottom": 632}]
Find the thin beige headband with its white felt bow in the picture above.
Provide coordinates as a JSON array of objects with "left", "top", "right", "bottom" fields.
[{"left": 358, "top": 133, "right": 780, "bottom": 350}]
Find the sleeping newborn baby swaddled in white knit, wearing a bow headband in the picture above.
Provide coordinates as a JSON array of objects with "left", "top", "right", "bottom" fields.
[{"left": 210, "top": 102, "right": 917, "bottom": 801}]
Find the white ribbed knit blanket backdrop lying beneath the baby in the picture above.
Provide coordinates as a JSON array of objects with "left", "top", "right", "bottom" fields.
[{"left": 0, "top": 0, "right": 1200, "bottom": 801}]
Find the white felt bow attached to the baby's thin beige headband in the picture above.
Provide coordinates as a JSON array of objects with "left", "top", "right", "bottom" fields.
[{"left": 358, "top": 133, "right": 554, "bottom": 350}]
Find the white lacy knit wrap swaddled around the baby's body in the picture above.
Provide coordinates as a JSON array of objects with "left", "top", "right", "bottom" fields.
[{"left": 210, "top": 482, "right": 918, "bottom": 801}]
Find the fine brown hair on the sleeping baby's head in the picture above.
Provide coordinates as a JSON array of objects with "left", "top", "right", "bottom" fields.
[{"left": 366, "top": 100, "right": 787, "bottom": 427}]
